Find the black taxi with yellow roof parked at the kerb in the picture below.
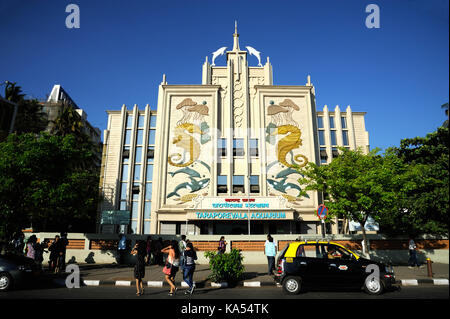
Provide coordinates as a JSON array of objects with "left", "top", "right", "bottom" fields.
[{"left": 275, "top": 241, "right": 395, "bottom": 295}]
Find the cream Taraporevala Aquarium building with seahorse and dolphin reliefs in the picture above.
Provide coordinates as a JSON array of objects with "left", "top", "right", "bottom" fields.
[{"left": 101, "top": 30, "right": 369, "bottom": 234}]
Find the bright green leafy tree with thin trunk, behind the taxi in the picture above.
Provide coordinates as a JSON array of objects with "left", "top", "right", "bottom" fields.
[{"left": 299, "top": 148, "right": 407, "bottom": 255}]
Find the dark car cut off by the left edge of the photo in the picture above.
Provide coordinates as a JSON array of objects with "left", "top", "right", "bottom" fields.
[{"left": 0, "top": 253, "right": 40, "bottom": 292}]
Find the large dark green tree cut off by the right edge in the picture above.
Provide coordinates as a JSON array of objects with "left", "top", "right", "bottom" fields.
[{"left": 384, "top": 127, "right": 449, "bottom": 235}]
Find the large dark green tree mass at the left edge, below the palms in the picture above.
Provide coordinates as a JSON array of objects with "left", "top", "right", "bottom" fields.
[{"left": 0, "top": 133, "right": 99, "bottom": 235}]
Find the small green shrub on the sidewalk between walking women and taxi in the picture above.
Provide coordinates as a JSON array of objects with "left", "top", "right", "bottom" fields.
[{"left": 205, "top": 249, "right": 244, "bottom": 286}]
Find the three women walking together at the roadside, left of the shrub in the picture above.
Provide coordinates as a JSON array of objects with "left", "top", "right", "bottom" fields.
[{"left": 131, "top": 235, "right": 197, "bottom": 296}]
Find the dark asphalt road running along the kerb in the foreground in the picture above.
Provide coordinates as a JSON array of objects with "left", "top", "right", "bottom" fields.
[{"left": 0, "top": 284, "right": 449, "bottom": 301}]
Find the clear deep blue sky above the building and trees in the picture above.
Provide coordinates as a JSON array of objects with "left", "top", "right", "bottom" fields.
[{"left": 0, "top": 0, "right": 449, "bottom": 149}]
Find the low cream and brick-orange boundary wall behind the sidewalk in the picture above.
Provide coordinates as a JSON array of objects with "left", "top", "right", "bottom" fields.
[{"left": 26, "top": 233, "right": 449, "bottom": 265}]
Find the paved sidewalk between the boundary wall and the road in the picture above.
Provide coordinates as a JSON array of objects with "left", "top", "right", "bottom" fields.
[{"left": 51, "top": 263, "right": 449, "bottom": 287}]
